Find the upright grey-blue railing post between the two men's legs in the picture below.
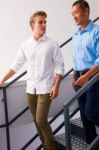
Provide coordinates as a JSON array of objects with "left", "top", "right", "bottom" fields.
[{"left": 64, "top": 105, "right": 72, "bottom": 150}]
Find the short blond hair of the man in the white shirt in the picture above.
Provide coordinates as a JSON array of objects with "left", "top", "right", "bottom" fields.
[{"left": 30, "top": 11, "right": 47, "bottom": 26}]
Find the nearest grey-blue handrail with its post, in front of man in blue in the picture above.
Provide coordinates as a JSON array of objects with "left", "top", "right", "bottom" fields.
[{"left": 64, "top": 72, "right": 99, "bottom": 150}]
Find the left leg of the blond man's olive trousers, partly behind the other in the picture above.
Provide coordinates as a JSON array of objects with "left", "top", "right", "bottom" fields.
[{"left": 27, "top": 94, "right": 44, "bottom": 143}]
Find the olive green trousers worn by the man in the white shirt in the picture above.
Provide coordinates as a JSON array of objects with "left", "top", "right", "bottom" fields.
[{"left": 27, "top": 93, "right": 55, "bottom": 150}]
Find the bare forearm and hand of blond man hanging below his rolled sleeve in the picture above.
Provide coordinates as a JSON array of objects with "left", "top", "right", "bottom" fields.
[{"left": 50, "top": 74, "right": 63, "bottom": 99}]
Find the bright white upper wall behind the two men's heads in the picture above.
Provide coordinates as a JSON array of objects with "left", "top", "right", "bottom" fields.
[{"left": 0, "top": 0, "right": 99, "bottom": 77}]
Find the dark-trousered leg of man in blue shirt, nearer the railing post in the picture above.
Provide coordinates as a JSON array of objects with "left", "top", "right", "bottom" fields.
[{"left": 74, "top": 74, "right": 97, "bottom": 144}]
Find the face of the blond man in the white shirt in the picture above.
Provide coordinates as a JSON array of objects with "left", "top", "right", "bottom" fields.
[{"left": 32, "top": 16, "right": 46, "bottom": 36}]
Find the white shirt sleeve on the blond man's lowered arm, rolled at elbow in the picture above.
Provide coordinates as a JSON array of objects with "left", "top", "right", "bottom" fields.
[{"left": 53, "top": 41, "right": 64, "bottom": 76}]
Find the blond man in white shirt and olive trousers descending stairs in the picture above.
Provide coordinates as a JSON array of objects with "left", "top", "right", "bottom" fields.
[{"left": 0, "top": 11, "right": 64, "bottom": 150}]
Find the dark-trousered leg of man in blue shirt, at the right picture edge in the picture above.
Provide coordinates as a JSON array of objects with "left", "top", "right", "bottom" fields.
[{"left": 85, "top": 81, "right": 99, "bottom": 126}]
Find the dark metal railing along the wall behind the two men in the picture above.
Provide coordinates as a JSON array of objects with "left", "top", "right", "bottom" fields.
[{"left": 0, "top": 17, "right": 99, "bottom": 150}]
